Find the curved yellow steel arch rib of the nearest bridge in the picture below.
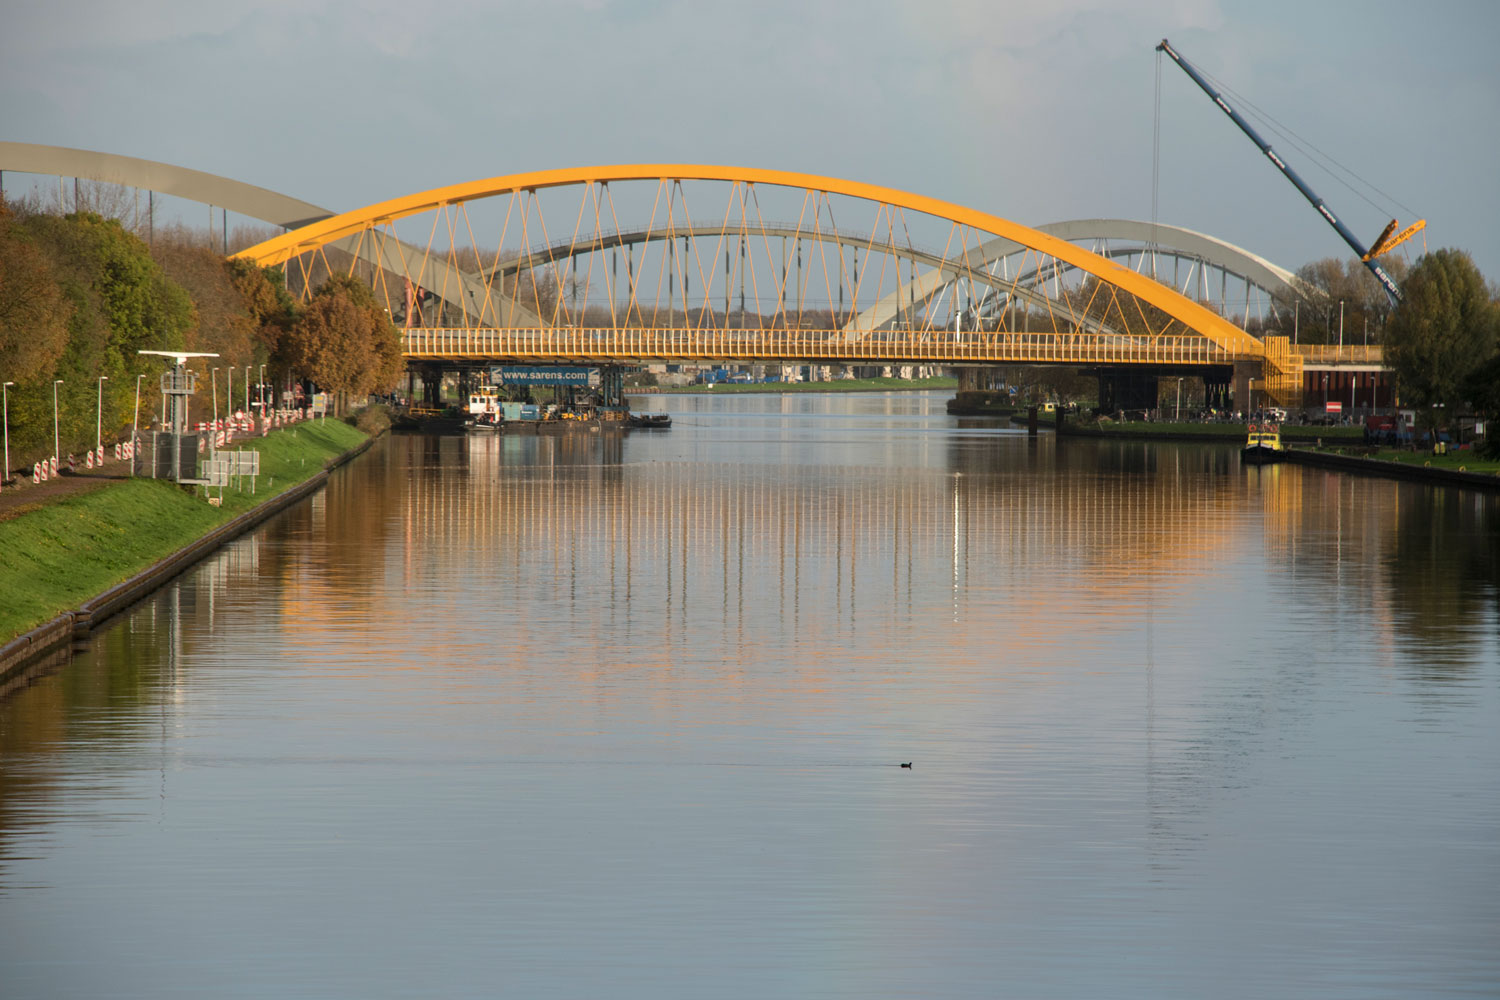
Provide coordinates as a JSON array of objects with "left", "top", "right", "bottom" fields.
[{"left": 236, "top": 163, "right": 1266, "bottom": 358}]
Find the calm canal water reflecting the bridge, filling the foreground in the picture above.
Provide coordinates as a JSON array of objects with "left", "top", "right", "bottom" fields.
[{"left": 0, "top": 393, "right": 1500, "bottom": 1000}]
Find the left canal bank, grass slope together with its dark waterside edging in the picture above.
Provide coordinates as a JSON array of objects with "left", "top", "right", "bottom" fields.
[{"left": 0, "top": 421, "right": 374, "bottom": 694}]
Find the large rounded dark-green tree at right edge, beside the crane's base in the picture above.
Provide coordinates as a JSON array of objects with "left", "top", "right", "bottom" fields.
[{"left": 1385, "top": 250, "right": 1500, "bottom": 426}]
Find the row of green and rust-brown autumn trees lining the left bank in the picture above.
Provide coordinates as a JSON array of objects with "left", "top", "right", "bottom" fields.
[{"left": 0, "top": 201, "right": 402, "bottom": 468}]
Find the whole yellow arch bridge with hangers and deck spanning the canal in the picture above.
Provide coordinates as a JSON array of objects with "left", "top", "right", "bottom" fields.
[{"left": 237, "top": 163, "right": 1302, "bottom": 405}]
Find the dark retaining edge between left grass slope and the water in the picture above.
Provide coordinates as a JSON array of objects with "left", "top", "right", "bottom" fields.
[{"left": 0, "top": 435, "right": 378, "bottom": 687}]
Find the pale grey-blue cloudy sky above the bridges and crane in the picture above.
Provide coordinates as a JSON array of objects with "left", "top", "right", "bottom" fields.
[{"left": 0, "top": 0, "right": 1500, "bottom": 282}]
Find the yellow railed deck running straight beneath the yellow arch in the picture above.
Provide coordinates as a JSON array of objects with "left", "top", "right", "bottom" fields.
[{"left": 402, "top": 327, "right": 1236, "bottom": 364}]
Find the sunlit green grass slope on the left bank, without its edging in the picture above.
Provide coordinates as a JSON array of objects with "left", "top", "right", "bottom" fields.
[{"left": 0, "top": 420, "right": 368, "bottom": 642}]
